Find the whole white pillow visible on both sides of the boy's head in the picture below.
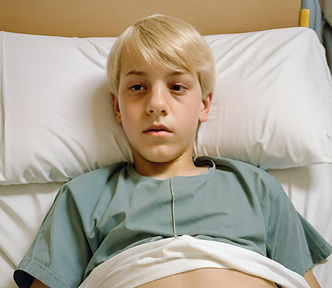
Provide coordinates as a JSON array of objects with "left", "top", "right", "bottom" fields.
[{"left": 0, "top": 28, "right": 332, "bottom": 184}]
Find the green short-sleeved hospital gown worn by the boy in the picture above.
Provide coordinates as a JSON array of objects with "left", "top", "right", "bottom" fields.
[{"left": 14, "top": 157, "right": 332, "bottom": 288}]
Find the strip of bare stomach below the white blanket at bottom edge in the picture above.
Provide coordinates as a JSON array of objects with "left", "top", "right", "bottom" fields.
[{"left": 139, "top": 268, "right": 278, "bottom": 288}]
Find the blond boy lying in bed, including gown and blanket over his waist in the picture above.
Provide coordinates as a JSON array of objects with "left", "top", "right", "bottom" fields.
[{"left": 14, "top": 15, "right": 332, "bottom": 288}]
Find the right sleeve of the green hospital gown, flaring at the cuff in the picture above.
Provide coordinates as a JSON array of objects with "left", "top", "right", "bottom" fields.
[{"left": 267, "top": 186, "right": 332, "bottom": 276}]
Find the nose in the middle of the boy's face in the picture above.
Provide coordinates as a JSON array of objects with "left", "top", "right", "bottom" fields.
[{"left": 146, "top": 85, "right": 168, "bottom": 115}]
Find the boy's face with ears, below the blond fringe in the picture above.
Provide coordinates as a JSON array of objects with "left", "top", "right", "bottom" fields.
[{"left": 113, "top": 53, "right": 211, "bottom": 163}]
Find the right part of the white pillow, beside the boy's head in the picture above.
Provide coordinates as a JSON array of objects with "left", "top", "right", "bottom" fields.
[{"left": 195, "top": 28, "right": 332, "bottom": 169}]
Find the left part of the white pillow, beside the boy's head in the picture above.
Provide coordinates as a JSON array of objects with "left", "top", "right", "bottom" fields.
[{"left": 0, "top": 32, "right": 131, "bottom": 184}]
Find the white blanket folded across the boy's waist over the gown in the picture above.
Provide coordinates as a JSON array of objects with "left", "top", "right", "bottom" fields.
[{"left": 79, "top": 235, "right": 310, "bottom": 288}]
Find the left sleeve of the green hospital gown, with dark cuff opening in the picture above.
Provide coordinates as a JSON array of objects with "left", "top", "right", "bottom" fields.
[{"left": 14, "top": 185, "right": 92, "bottom": 288}]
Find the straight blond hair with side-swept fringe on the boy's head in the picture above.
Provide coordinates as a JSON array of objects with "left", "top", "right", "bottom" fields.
[{"left": 107, "top": 15, "right": 215, "bottom": 100}]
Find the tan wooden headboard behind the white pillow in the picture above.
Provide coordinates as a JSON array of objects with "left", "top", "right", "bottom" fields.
[{"left": 0, "top": 0, "right": 301, "bottom": 37}]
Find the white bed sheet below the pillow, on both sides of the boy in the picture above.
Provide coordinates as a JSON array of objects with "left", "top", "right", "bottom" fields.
[{"left": 0, "top": 164, "right": 332, "bottom": 288}]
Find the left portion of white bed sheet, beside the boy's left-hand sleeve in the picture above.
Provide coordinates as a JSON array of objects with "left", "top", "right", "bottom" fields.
[{"left": 0, "top": 183, "right": 63, "bottom": 288}]
